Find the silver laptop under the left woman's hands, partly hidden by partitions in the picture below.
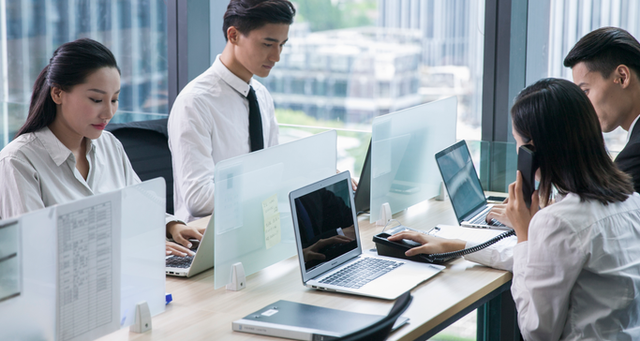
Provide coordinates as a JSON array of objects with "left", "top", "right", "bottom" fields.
[{"left": 165, "top": 215, "right": 215, "bottom": 277}]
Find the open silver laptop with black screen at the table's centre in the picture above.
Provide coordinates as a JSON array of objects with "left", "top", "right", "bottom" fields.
[{"left": 289, "top": 171, "right": 443, "bottom": 300}]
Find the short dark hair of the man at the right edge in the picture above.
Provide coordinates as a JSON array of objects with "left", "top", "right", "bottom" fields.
[{"left": 564, "top": 27, "right": 640, "bottom": 78}]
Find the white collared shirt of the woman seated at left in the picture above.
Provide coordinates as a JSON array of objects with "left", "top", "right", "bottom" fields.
[{"left": 0, "top": 127, "right": 178, "bottom": 223}]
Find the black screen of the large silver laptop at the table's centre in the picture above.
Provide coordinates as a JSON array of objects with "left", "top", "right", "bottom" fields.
[{"left": 294, "top": 180, "right": 358, "bottom": 272}]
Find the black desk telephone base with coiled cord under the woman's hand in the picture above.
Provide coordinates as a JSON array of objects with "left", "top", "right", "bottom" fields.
[{"left": 373, "top": 225, "right": 515, "bottom": 264}]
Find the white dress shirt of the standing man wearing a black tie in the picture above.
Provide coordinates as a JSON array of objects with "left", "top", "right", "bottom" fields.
[{"left": 168, "top": 55, "right": 278, "bottom": 221}]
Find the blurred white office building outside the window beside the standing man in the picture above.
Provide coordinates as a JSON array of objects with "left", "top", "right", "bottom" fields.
[{"left": 261, "top": 23, "right": 422, "bottom": 126}]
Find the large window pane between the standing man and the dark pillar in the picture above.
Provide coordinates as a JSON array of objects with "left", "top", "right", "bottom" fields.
[{"left": 258, "top": 0, "right": 484, "bottom": 178}]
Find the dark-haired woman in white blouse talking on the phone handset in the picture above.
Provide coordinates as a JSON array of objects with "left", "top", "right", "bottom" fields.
[{"left": 390, "top": 79, "right": 640, "bottom": 340}]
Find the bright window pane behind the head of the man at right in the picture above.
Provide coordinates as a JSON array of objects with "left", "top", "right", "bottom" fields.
[{"left": 527, "top": 0, "right": 640, "bottom": 156}]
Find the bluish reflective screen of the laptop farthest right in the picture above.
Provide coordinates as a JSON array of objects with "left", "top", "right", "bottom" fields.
[{"left": 436, "top": 140, "right": 486, "bottom": 220}]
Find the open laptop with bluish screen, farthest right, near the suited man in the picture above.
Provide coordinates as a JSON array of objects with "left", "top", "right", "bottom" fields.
[{"left": 436, "top": 140, "right": 509, "bottom": 230}]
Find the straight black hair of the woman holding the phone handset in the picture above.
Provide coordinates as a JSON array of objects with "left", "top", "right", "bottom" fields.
[{"left": 511, "top": 78, "right": 633, "bottom": 205}]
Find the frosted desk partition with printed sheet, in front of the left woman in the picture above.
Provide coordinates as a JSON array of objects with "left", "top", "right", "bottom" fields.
[{"left": 0, "top": 179, "right": 165, "bottom": 340}]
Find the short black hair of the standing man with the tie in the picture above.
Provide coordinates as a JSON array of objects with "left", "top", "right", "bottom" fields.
[{"left": 222, "top": 0, "right": 296, "bottom": 40}]
